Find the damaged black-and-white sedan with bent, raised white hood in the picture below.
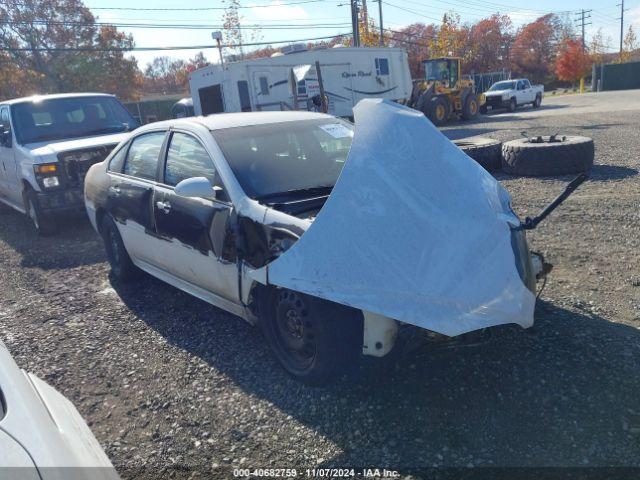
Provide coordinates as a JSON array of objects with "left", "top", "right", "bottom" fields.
[{"left": 85, "top": 100, "right": 576, "bottom": 383}]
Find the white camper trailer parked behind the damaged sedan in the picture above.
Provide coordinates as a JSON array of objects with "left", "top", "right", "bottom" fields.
[{"left": 189, "top": 45, "right": 412, "bottom": 117}]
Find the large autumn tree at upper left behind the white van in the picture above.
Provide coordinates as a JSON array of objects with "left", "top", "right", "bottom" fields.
[{"left": 0, "top": 0, "right": 141, "bottom": 99}]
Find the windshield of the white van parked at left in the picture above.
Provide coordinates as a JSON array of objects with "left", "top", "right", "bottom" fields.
[{"left": 12, "top": 96, "right": 139, "bottom": 144}]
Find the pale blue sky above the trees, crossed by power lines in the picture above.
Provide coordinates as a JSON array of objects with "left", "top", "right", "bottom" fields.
[{"left": 86, "top": 0, "right": 640, "bottom": 68}]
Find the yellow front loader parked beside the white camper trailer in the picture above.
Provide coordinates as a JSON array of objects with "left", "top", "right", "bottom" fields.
[{"left": 408, "top": 57, "right": 485, "bottom": 125}]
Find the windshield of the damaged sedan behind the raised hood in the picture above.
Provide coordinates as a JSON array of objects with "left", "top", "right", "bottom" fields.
[{"left": 212, "top": 118, "right": 353, "bottom": 199}]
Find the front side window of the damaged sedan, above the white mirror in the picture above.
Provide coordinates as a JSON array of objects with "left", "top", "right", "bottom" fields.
[{"left": 164, "top": 132, "right": 216, "bottom": 187}]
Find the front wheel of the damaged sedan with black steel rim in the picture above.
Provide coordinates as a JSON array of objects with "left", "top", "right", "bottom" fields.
[{"left": 260, "top": 289, "right": 363, "bottom": 385}]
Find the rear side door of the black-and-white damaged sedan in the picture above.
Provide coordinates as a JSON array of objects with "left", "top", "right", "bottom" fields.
[{"left": 106, "top": 130, "right": 166, "bottom": 265}]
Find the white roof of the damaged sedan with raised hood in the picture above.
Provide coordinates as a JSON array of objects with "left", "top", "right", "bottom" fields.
[{"left": 136, "top": 111, "right": 336, "bottom": 131}]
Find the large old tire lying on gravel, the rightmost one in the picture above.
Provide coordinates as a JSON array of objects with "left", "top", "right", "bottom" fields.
[{"left": 502, "top": 137, "right": 594, "bottom": 176}]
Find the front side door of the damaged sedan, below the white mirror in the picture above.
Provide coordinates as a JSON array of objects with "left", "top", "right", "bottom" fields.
[{"left": 154, "top": 131, "right": 239, "bottom": 301}]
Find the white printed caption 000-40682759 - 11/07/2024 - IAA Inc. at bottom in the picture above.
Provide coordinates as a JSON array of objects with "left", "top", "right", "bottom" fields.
[{"left": 233, "top": 468, "right": 400, "bottom": 478}]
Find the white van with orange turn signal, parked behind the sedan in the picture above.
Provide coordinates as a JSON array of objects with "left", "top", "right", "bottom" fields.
[{"left": 0, "top": 93, "right": 138, "bottom": 235}]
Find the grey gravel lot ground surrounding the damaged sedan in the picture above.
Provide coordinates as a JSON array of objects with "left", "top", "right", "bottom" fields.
[{"left": 0, "top": 92, "right": 640, "bottom": 478}]
